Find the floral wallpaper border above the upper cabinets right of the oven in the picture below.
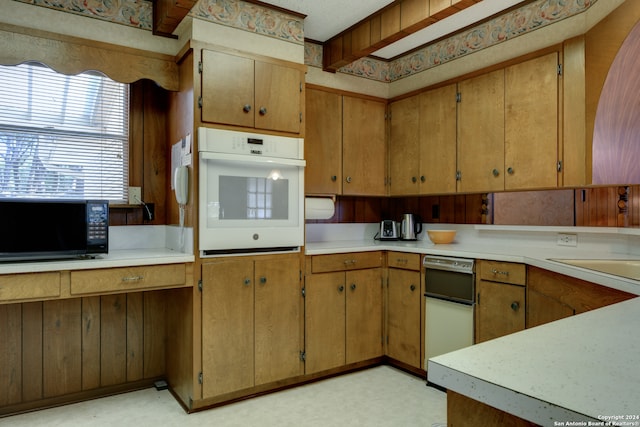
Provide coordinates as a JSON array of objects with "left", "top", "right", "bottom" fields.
[{"left": 305, "top": 0, "right": 598, "bottom": 82}]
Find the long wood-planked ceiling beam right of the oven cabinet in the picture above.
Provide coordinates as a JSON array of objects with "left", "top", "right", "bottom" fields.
[{"left": 322, "top": 0, "right": 482, "bottom": 72}]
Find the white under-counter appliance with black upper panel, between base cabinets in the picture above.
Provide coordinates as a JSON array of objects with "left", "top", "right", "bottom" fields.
[{"left": 422, "top": 255, "right": 475, "bottom": 367}]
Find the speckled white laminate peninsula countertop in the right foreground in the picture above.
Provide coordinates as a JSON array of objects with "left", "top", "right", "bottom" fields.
[{"left": 427, "top": 298, "right": 640, "bottom": 426}]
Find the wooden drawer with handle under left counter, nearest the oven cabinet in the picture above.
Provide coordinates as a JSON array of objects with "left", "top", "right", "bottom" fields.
[{"left": 71, "top": 264, "right": 186, "bottom": 295}]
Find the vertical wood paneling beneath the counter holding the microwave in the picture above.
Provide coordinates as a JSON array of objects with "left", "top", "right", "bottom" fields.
[{"left": 0, "top": 291, "right": 166, "bottom": 416}]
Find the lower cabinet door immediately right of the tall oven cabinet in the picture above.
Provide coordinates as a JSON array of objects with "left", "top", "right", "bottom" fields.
[{"left": 305, "top": 272, "right": 345, "bottom": 374}]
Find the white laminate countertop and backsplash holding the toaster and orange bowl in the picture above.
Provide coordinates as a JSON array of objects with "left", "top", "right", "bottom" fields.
[{"left": 305, "top": 226, "right": 640, "bottom": 295}]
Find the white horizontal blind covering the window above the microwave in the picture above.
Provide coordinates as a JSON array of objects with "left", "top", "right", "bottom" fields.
[{"left": 0, "top": 64, "right": 129, "bottom": 203}]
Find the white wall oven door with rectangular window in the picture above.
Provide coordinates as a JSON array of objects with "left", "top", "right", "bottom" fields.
[{"left": 199, "top": 152, "right": 305, "bottom": 256}]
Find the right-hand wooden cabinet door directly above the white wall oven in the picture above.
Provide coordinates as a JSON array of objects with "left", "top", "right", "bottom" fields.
[{"left": 254, "top": 61, "right": 303, "bottom": 133}]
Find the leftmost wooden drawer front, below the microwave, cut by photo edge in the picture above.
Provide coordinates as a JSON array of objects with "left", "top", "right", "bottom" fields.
[{"left": 0, "top": 271, "right": 60, "bottom": 302}]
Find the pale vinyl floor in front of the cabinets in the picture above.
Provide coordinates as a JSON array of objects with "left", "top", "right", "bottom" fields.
[{"left": 0, "top": 366, "right": 446, "bottom": 427}]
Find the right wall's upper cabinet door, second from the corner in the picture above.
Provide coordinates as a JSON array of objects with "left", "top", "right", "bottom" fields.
[{"left": 419, "top": 84, "right": 457, "bottom": 194}]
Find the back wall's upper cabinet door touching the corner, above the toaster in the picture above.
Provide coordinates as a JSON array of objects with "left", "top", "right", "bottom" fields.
[{"left": 342, "top": 96, "right": 387, "bottom": 196}]
